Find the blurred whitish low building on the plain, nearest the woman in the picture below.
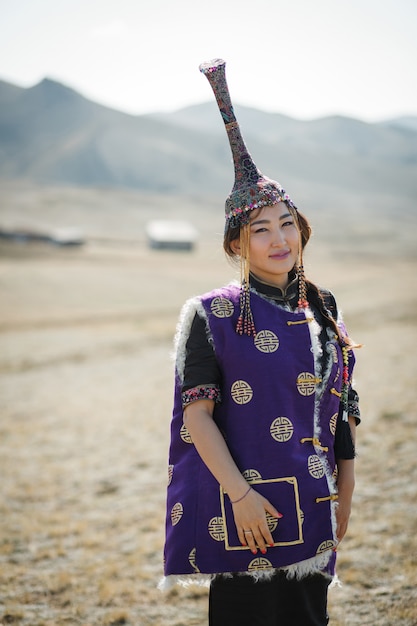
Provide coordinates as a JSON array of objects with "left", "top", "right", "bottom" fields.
[{"left": 146, "top": 220, "right": 197, "bottom": 251}]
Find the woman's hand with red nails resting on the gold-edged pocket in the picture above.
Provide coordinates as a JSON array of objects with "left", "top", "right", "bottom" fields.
[{"left": 232, "top": 488, "right": 282, "bottom": 554}]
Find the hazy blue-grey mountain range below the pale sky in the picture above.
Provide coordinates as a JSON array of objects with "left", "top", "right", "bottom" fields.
[{"left": 0, "top": 74, "right": 417, "bottom": 210}]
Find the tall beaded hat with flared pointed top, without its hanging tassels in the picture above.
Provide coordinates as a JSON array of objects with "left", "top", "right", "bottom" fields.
[{"left": 200, "top": 59, "right": 296, "bottom": 227}]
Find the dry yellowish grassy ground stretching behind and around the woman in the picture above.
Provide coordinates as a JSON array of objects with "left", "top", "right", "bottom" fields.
[{"left": 0, "top": 193, "right": 417, "bottom": 626}]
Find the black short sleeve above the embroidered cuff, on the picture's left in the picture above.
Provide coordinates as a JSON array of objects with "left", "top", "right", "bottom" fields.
[{"left": 182, "top": 313, "right": 221, "bottom": 391}]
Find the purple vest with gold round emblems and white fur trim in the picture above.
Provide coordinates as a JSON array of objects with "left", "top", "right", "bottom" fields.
[{"left": 165, "top": 285, "right": 352, "bottom": 577}]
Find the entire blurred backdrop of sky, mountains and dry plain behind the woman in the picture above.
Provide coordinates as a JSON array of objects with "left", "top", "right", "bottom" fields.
[{"left": 0, "top": 0, "right": 417, "bottom": 626}]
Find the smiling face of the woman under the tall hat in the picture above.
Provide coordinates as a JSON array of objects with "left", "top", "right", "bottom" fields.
[{"left": 233, "top": 202, "right": 300, "bottom": 288}]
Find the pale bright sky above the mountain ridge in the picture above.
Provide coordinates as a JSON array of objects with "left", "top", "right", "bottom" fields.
[{"left": 0, "top": 0, "right": 417, "bottom": 122}]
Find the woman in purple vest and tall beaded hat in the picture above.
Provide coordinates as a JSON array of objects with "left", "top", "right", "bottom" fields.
[{"left": 161, "top": 60, "right": 359, "bottom": 626}]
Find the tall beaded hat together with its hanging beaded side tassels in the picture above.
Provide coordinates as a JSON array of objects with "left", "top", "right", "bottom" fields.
[{"left": 199, "top": 59, "right": 308, "bottom": 336}]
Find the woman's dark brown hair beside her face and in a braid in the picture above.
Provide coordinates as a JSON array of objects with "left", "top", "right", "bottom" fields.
[{"left": 223, "top": 201, "right": 346, "bottom": 342}]
